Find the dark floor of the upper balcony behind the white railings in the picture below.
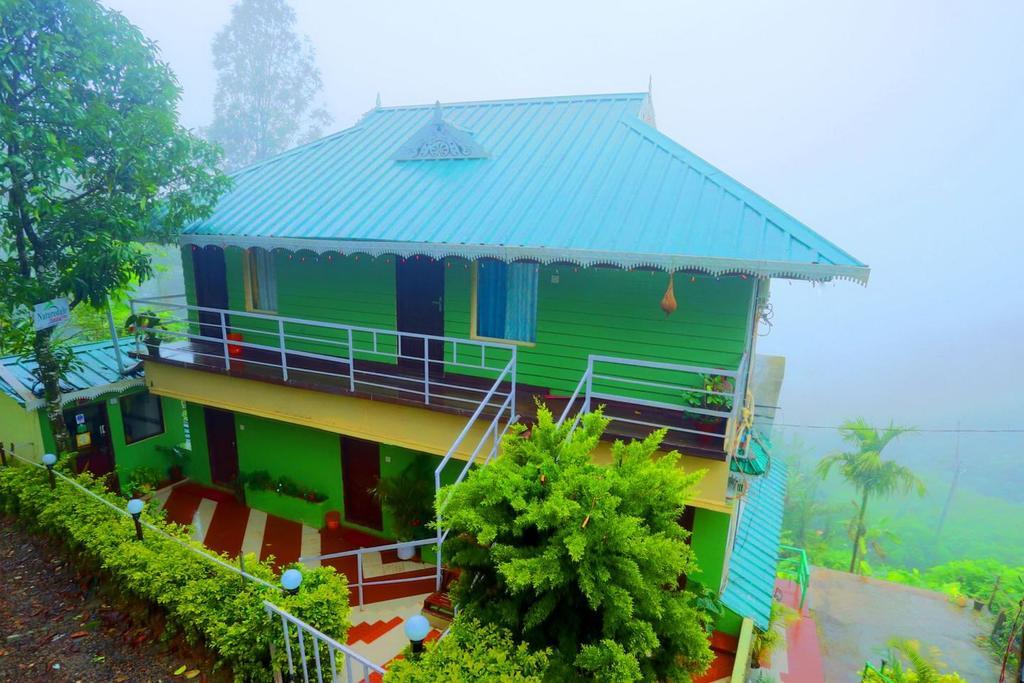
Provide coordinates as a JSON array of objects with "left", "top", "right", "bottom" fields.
[{"left": 140, "top": 342, "right": 725, "bottom": 461}]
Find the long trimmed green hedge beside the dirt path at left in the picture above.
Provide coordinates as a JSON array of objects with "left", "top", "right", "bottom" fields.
[{"left": 0, "top": 458, "right": 349, "bottom": 681}]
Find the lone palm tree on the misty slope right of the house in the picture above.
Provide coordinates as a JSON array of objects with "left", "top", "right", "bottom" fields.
[{"left": 817, "top": 418, "right": 925, "bottom": 573}]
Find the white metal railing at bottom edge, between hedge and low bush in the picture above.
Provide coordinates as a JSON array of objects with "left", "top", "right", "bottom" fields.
[{"left": 263, "top": 600, "right": 384, "bottom": 683}]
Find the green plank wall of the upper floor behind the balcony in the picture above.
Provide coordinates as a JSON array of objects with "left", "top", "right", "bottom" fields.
[{"left": 182, "top": 246, "right": 756, "bottom": 398}]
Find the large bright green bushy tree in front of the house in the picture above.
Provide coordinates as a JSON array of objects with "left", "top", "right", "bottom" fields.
[{"left": 437, "top": 407, "right": 712, "bottom": 681}]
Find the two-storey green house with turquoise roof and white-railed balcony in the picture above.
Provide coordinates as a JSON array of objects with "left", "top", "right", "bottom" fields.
[{"left": 125, "top": 93, "right": 868, "bottom": 647}]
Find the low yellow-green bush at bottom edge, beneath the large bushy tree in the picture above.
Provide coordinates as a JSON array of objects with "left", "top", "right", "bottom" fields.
[{"left": 384, "top": 616, "right": 548, "bottom": 683}]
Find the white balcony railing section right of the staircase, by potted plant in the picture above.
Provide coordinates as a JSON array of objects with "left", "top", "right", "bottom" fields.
[{"left": 558, "top": 354, "right": 748, "bottom": 451}]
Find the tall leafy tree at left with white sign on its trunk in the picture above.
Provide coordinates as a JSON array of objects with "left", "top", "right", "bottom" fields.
[{"left": 0, "top": 0, "right": 227, "bottom": 452}]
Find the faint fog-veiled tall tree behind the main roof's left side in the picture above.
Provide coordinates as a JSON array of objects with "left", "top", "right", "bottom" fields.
[{"left": 207, "top": 0, "right": 331, "bottom": 170}]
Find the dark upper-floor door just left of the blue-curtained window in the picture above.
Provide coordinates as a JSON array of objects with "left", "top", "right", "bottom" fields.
[{"left": 395, "top": 256, "right": 444, "bottom": 373}]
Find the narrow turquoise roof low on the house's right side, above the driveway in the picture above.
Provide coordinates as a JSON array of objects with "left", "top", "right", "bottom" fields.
[{"left": 722, "top": 458, "right": 786, "bottom": 630}]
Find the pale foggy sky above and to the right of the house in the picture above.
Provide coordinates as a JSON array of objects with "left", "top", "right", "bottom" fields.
[{"left": 108, "top": 0, "right": 1024, "bottom": 463}]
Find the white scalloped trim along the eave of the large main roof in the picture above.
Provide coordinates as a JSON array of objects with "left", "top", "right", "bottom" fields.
[{"left": 181, "top": 234, "right": 870, "bottom": 285}]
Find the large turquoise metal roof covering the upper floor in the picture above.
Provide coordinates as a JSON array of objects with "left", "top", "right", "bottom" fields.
[{"left": 183, "top": 93, "right": 868, "bottom": 283}]
